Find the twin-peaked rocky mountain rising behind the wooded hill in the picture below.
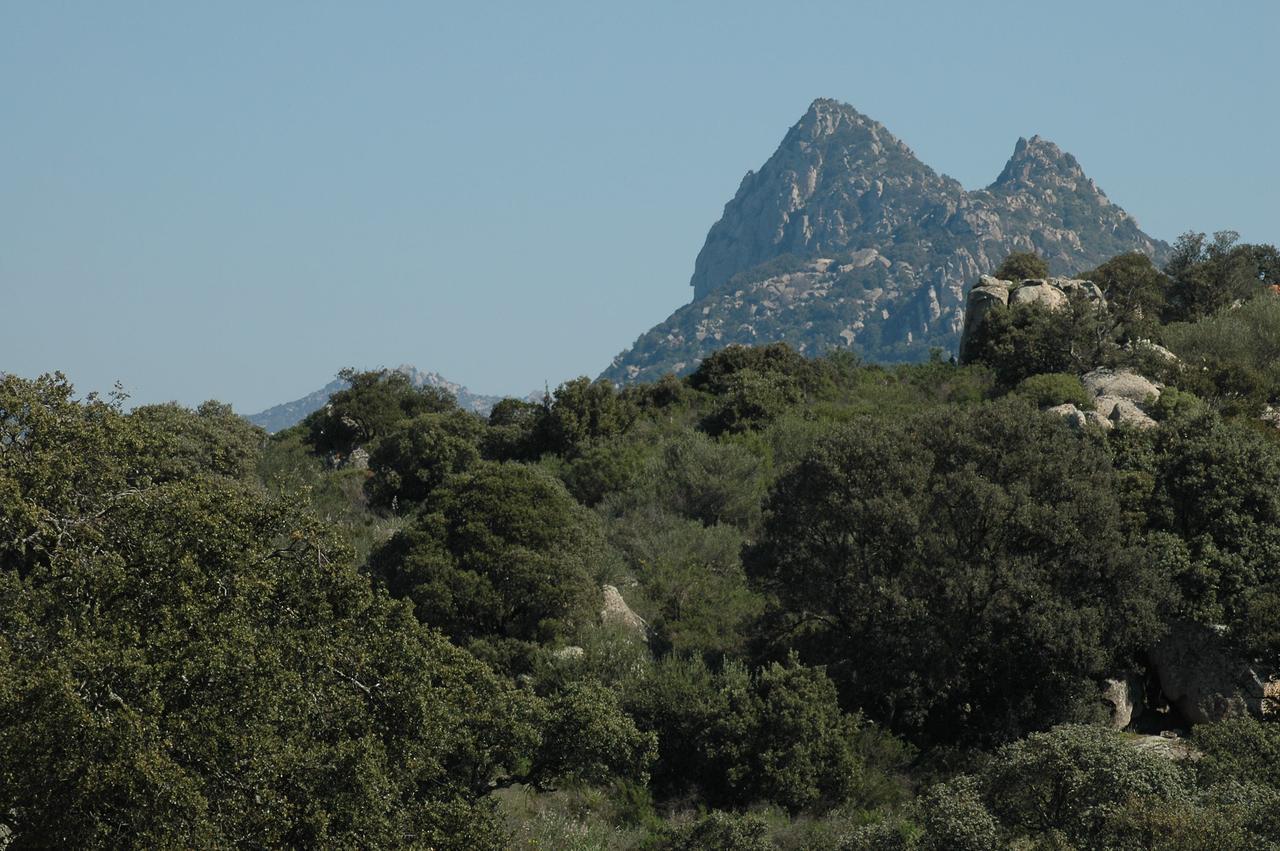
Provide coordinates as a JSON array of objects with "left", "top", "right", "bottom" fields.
[{"left": 603, "top": 99, "right": 1169, "bottom": 383}]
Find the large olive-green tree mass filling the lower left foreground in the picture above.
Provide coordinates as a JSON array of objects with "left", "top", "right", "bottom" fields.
[{"left": 0, "top": 378, "right": 538, "bottom": 848}]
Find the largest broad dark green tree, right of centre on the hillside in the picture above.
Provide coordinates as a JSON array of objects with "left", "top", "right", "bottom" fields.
[{"left": 748, "top": 401, "right": 1165, "bottom": 741}]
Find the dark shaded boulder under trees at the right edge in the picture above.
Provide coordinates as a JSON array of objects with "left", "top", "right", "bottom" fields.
[{"left": 1148, "top": 621, "right": 1280, "bottom": 724}]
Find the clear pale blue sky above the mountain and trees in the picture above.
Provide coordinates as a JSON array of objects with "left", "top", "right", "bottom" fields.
[{"left": 0, "top": 0, "right": 1280, "bottom": 413}]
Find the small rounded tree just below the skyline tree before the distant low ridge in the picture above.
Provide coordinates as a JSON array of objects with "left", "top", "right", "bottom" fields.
[{"left": 365, "top": 410, "right": 484, "bottom": 507}]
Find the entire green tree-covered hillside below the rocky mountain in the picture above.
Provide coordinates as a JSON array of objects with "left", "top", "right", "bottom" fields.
[{"left": 0, "top": 234, "right": 1280, "bottom": 851}]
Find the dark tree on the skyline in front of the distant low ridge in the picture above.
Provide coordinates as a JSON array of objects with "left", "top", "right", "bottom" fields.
[{"left": 303, "top": 369, "right": 457, "bottom": 456}]
